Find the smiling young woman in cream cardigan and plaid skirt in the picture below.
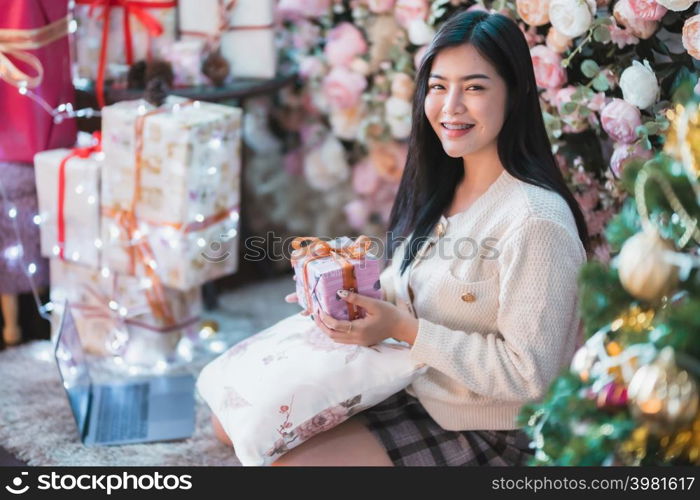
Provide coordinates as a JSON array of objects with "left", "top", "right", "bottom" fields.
[{"left": 215, "top": 11, "right": 588, "bottom": 465}]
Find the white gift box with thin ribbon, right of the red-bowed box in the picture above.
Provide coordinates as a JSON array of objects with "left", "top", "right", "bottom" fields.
[{"left": 179, "top": 0, "right": 277, "bottom": 78}]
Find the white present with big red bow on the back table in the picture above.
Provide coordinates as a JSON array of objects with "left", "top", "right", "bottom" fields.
[{"left": 75, "top": 0, "right": 177, "bottom": 107}]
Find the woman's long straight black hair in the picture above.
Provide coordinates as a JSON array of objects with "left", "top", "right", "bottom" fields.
[{"left": 389, "top": 11, "right": 589, "bottom": 273}]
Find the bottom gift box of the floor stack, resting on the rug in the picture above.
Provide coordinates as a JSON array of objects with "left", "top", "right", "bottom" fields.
[{"left": 50, "top": 259, "right": 202, "bottom": 365}]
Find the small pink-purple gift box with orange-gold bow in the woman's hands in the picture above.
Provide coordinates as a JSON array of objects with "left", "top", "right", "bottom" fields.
[{"left": 292, "top": 236, "right": 382, "bottom": 320}]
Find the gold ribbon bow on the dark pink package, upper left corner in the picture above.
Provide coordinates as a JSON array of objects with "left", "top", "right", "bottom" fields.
[{"left": 0, "top": 17, "right": 70, "bottom": 89}]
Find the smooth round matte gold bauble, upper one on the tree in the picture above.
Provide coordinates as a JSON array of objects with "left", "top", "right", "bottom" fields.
[{"left": 618, "top": 229, "right": 678, "bottom": 303}]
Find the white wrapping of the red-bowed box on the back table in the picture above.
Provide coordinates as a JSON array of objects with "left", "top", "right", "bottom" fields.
[{"left": 74, "top": 0, "right": 177, "bottom": 80}]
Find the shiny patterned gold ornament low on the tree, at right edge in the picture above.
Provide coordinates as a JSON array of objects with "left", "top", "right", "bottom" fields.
[{"left": 627, "top": 347, "right": 698, "bottom": 435}]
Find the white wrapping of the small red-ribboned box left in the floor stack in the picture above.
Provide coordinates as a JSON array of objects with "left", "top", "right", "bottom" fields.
[{"left": 34, "top": 149, "right": 104, "bottom": 268}]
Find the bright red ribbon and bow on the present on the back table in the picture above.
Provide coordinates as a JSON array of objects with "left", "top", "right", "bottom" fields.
[{"left": 76, "top": 0, "right": 177, "bottom": 108}]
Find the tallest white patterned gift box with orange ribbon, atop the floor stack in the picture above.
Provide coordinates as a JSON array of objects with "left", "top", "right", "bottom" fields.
[{"left": 101, "top": 97, "right": 241, "bottom": 290}]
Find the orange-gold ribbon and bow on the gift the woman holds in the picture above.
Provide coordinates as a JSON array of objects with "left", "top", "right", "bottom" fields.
[{"left": 291, "top": 235, "right": 372, "bottom": 320}]
